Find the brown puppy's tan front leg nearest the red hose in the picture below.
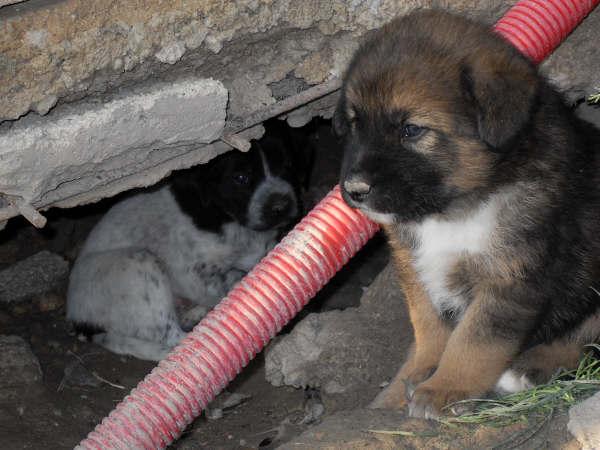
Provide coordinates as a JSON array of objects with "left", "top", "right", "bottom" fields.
[{"left": 369, "top": 240, "right": 450, "bottom": 409}]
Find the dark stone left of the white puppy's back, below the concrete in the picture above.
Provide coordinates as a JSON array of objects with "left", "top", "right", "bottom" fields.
[{"left": 0, "top": 250, "right": 69, "bottom": 309}]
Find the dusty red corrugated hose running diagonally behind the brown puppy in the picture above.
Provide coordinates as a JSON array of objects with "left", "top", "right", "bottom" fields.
[{"left": 76, "top": 0, "right": 600, "bottom": 450}]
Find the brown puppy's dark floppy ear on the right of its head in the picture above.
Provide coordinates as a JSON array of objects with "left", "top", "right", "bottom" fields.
[{"left": 461, "top": 51, "right": 538, "bottom": 150}]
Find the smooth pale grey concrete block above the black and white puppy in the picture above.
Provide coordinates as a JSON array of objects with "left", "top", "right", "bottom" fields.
[{"left": 0, "top": 79, "right": 227, "bottom": 219}]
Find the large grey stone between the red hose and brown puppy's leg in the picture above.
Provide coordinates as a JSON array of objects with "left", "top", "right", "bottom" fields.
[{"left": 265, "top": 264, "right": 412, "bottom": 404}]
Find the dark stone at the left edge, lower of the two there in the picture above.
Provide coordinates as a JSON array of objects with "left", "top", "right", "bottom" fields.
[{"left": 0, "top": 335, "right": 42, "bottom": 389}]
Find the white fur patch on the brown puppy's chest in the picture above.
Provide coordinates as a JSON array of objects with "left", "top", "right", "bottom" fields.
[{"left": 414, "top": 198, "right": 499, "bottom": 317}]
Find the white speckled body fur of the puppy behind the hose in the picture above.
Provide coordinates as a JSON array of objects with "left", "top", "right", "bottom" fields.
[{"left": 67, "top": 187, "right": 291, "bottom": 360}]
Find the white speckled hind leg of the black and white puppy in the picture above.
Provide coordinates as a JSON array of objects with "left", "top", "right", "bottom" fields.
[{"left": 67, "top": 249, "right": 185, "bottom": 360}]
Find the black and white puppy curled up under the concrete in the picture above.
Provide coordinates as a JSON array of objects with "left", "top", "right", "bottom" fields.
[{"left": 67, "top": 128, "right": 300, "bottom": 360}]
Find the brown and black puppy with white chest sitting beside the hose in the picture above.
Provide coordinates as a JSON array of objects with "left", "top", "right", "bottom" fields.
[{"left": 334, "top": 11, "right": 600, "bottom": 417}]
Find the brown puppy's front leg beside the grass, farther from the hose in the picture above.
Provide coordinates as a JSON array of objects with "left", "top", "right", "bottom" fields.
[{"left": 409, "top": 290, "right": 535, "bottom": 418}]
